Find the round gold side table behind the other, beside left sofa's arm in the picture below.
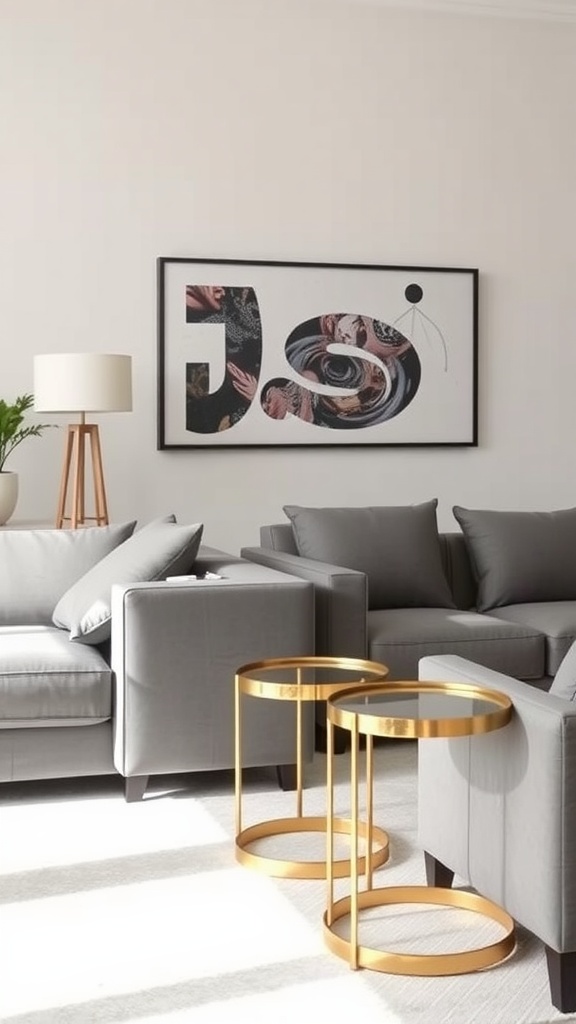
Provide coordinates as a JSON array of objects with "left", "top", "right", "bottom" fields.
[{"left": 234, "top": 656, "right": 388, "bottom": 879}]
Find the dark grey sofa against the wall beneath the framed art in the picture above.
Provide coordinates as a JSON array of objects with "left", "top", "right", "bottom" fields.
[{"left": 242, "top": 501, "right": 576, "bottom": 689}]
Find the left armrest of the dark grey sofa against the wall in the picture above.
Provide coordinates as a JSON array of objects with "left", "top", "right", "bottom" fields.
[{"left": 241, "top": 548, "right": 368, "bottom": 657}]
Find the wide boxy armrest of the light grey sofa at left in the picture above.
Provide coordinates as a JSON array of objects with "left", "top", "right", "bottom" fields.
[{"left": 111, "top": 569, "right": 314, "bottom": 776}]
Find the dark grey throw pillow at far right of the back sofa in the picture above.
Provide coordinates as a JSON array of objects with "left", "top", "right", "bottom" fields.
[{"left": 453, "top": 505, "right": 576, "bottom": 611}]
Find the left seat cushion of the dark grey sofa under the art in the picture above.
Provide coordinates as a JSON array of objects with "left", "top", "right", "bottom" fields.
[{"left": 368, "top": 608, "right": 545, "bottom": 679}]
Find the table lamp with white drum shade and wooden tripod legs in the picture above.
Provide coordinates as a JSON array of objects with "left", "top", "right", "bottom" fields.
[{"left": 34, "top": 352, "right": 132, "bottom": 529}]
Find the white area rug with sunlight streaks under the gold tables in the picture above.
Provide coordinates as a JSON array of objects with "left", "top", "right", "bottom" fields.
[{"left": 0, "top": 742, "right": 565, "bottom": 1024}]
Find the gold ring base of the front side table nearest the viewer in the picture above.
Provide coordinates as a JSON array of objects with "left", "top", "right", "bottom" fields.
[{"left": 324, "top": 886, "right": 516, "bottom": 977}]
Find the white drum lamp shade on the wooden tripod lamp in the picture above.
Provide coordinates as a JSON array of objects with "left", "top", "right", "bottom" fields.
[{"left": 34, "top": 352, "right": 132, "bottom": 413}]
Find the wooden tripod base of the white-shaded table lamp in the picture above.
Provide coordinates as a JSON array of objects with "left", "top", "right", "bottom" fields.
[{"left": 56, "top": 423, "right": 109, "bottom": 529}]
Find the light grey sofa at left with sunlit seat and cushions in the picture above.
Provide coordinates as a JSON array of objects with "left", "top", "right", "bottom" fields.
[{"left": 0, "top": 521, "right": 314, "bottom": 799}]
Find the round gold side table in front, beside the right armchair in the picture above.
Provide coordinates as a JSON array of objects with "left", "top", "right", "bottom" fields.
[{"left": 324, "top": 682, "right": 516, "bottom": 975}]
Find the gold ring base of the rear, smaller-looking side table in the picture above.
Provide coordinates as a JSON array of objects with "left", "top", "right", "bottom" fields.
[{"left": 236, "top": 816, "right": 389, "bottom": 879}]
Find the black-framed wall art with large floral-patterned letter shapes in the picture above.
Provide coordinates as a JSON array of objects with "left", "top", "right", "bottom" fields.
[{"left": 158, "top": 256, "right": 479, "bottom": 450}]
